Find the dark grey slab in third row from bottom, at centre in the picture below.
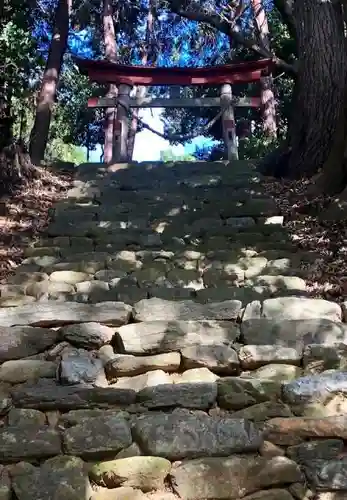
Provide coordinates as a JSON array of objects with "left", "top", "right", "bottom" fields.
[{"left": 137, "top": 382, "right": 217, "bottom": 409}]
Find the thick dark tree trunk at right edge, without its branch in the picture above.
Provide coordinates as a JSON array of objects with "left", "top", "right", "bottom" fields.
[{"left": 288, "top": 0, "right": 347, "bottom": 178}]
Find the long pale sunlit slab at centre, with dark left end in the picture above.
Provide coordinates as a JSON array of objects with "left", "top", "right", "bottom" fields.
[{"left": 115, "top": 320, "right": 239, "bottom": 354}]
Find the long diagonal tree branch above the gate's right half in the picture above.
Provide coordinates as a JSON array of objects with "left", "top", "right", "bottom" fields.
[{"left": 168, "top": 0, "right": 297, "bottom": 74}]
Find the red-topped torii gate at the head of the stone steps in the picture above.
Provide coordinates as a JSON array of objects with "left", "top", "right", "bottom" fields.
[{"left": 75, "top": 58, "right": 273, "bottom": 162}]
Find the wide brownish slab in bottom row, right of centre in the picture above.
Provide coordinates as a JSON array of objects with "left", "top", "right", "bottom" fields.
[{"left": 171, "top": 457, "right": 303, "bottom": 500}]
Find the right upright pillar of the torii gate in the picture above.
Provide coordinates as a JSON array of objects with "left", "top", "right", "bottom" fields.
[{"left": 220, "top": 84, "right": 239, "bottom": 160}]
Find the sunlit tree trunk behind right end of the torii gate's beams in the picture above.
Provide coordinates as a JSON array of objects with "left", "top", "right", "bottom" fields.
[{"left": 251, "top": 0, "right": 277, "bottom": 139}]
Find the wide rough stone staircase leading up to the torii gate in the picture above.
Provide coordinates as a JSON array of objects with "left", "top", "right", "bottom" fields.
[{"left": 0, "top": 161, "right": 347, "bottom": 500}]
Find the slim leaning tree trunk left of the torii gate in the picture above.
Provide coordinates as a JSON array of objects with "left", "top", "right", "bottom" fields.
[{"left": 30, "top": 0, "right": 72, "bottom": 165}]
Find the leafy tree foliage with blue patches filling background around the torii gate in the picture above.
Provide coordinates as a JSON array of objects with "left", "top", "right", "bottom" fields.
[{"left": 0, "top": 0, "right": 296, "bottom": 161}]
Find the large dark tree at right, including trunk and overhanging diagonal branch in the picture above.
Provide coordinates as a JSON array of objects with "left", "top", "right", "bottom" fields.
[{"left": 164, "top": 0, "right": 346, "bottom": 192}]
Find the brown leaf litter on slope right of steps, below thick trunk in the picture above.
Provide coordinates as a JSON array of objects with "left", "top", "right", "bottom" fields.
[{"left": 265, "top": 178, "right": 347, "bottom": 302}]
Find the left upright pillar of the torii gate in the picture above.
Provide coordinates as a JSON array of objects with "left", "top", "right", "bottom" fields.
[{"left": 112, "top": 84, "right": 131, "bottom": 163}]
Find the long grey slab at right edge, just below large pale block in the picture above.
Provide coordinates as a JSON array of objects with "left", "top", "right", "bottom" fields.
[{"left": 241, "top": 318, "right": 347, "bottom": 348}]
